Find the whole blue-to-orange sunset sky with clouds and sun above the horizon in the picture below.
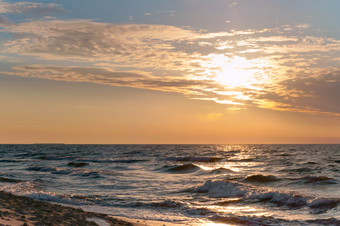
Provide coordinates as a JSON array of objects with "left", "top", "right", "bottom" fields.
[{"left": 0, "top": 0, "right": 340, "bottom": 144}]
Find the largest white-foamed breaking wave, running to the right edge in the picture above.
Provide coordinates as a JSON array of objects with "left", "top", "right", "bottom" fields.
[{"left": 193, "top": 180, "right": 340, "bottom": 214}]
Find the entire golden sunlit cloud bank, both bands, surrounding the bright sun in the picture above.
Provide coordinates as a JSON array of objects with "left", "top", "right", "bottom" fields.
[{"left": 1, "top": 17, "right": 340, "bottom": 115}]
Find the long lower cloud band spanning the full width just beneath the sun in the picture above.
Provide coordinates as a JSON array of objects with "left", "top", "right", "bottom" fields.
[{"left": 5, "top": 62, "right": 340, "bottom": 116}]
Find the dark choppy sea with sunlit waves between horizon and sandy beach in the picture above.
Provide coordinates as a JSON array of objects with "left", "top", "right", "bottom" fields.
[{"left": 0, "top": 144, "right": 340, "bottom": 225}]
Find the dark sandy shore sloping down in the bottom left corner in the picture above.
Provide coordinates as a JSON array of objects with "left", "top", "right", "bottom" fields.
[{"left": 0, "top": 191, "right": 149, "bottom": 226}]
